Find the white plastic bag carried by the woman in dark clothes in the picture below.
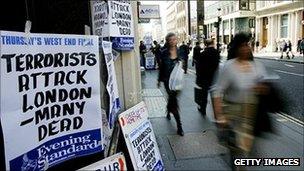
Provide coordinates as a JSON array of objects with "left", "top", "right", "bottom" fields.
[{"left": 169, "top": 61, "right": 184, "bottom": 91}]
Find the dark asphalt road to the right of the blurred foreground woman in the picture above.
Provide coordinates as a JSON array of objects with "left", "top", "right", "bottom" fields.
[{"left": 189, "top": 58, "right": 304, "bottom": 122}]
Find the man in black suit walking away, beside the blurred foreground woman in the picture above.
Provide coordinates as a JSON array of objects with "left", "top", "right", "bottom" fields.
[{"left": 196, "top": 39, "right": 220, "bottom": 115}]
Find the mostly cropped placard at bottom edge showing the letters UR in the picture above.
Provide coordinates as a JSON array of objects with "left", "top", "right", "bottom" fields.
[{"left": 78, "top": 153, "right": 127, "bottom": 171}]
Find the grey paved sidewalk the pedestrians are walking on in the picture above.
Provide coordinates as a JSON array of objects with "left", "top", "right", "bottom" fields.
[{"left": 142, "top": 70, "right": 304, "bottom": 170}]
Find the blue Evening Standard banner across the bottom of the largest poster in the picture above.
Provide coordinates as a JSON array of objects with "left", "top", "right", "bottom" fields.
[{"left": 10, "top": 130, "right": 102, "bottom": 171}]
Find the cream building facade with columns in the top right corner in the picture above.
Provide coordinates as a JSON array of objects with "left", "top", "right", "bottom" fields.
[{"left": 255, "top": 0, "right": 304, "bottom": 52}]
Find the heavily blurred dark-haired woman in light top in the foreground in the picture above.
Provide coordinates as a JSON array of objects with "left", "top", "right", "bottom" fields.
[{"left": 213, "top": 33, "right": 267, "bottom": 164}]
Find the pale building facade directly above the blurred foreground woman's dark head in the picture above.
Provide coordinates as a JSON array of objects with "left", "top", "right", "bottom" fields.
[{"left": 204, "top": 0, "right": 256, "bottom": 45}]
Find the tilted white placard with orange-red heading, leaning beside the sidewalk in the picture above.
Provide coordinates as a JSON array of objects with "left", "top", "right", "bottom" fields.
[{"left": 119, "top": 102, "right": 164, "bottom": 170}]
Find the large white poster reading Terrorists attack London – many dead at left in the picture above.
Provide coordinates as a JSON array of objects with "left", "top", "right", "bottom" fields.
[{"left": 0, "top": 31, "right": 103, "bottom": 171}]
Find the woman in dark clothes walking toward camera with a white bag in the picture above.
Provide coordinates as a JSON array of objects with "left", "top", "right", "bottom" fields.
[{"left": 157, "top": 33, "right": 184, "bottom": 136}]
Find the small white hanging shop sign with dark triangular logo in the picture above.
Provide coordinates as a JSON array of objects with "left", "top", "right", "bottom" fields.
[{"left": 138, "top": 5, "right": 160, "bottom": 19}]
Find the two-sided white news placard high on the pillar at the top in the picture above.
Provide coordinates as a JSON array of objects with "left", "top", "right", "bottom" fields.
[{"left": 91, "top": 0, "right": 134, "bottom": 51}]
